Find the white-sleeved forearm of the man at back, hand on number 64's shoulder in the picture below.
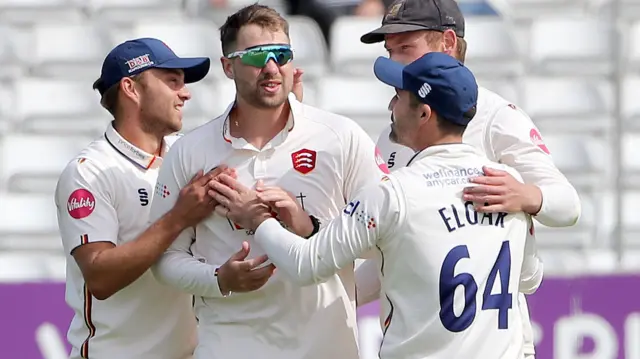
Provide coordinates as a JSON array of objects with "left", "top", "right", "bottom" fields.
[{"left": 535, "top": 184, "right": 581, "bottom": 227}]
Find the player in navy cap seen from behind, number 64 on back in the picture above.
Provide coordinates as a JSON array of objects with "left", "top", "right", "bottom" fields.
[{"left": 215, "top": 53, "right": 540, "bottom": 359}]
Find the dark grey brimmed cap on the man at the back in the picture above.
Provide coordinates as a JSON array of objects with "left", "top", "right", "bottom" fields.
[{"left": 360, "top": 0, "right": 464, "bottom": 44}]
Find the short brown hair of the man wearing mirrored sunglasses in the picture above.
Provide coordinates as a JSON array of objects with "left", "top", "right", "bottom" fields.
[{"left": 220, "top": 3, "right": 289, "bottom": 56}]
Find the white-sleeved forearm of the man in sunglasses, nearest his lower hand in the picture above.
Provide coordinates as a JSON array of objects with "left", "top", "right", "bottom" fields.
[{"left": 152, "top": 249, "right": 228, "bottom": 298}]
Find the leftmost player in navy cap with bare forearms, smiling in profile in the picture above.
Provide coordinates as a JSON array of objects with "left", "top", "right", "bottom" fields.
[{"left": 55, "top": 38, "right": 221, "bottom": 359}]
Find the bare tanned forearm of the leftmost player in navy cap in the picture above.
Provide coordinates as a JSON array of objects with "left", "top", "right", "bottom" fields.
[{"left": 90, "top": 212, "right": 182, "bottom": 299}]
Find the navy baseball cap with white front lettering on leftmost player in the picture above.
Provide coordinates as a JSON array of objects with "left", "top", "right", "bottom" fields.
[{"left": 93, "top": 38, "right": 211, "bottom": 95}]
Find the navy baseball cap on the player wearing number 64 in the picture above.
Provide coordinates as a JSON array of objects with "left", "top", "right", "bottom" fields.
[{"left": 373, "top": 52, "right": 478, "bottom": 126}]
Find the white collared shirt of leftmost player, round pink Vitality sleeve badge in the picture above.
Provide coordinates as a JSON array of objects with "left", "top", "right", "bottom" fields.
[{"left": 55, "top": 125, "right": 197, "bottom": 359}]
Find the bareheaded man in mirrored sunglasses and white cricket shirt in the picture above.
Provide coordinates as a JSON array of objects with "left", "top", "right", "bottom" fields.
[{"left": 151, "top": 4, "right": 387, "bottom": 359}]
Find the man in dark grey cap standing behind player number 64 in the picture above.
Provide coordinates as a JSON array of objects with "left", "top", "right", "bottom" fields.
[{"left": 357, "top": 0, "right": 581, "bottom": 358}]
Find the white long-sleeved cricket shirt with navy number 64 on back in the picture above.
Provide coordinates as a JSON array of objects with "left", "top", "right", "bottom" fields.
[{"left": 255, "top": 144, "right": 537, "bottom": 359}]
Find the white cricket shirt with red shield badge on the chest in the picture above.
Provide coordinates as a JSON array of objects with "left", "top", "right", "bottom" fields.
[{"left": 151, "top": 96, "right": 386, "bottom": 359}]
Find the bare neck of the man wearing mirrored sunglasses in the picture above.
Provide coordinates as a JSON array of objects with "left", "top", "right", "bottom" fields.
[{"left": 229, "top": 98, "right": 291, "bottom": 149}]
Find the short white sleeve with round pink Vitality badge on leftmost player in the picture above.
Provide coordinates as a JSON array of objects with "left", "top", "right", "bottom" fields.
[{"left": 55, "top": 158, "right": 118, "bottom": 254}]
